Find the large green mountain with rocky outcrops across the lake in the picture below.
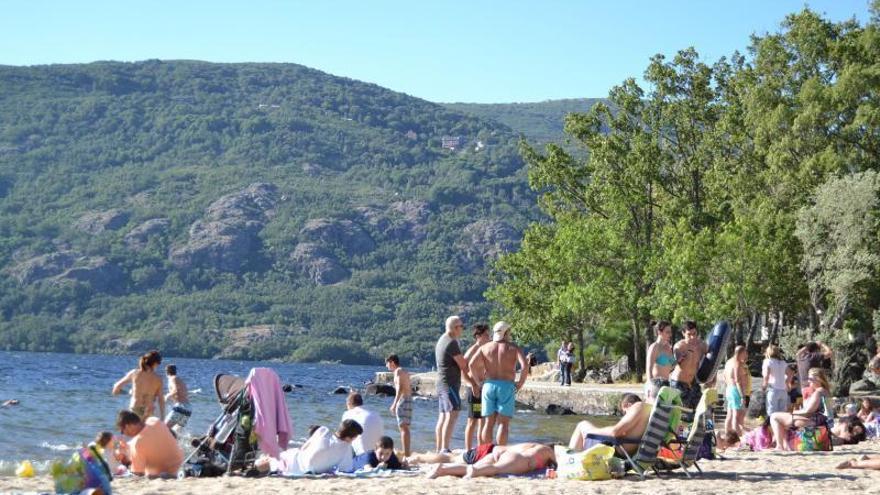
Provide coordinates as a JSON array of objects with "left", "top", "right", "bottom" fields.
[{"left": 0, "top": 61, "right": 536, "bottom": 362}]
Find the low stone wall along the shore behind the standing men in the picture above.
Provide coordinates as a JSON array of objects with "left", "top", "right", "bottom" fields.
[{"left": 375, "top": 372, "right": 642, "bottom": 416}]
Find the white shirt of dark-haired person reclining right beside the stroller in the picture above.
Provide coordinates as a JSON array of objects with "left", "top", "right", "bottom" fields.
[{"left": 269, "top": 426, "right": 354, "bottom": 475}]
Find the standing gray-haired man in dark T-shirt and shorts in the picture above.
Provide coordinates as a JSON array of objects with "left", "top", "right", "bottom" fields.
[{"left": 434, "top": 316, "right": 470, "bottom": 452}]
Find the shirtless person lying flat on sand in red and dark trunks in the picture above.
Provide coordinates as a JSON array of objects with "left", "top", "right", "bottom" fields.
[{"left": 428, "top": 442, "right": 556, "bottom": 478}]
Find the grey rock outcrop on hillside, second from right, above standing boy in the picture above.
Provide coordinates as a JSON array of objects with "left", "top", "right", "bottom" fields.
[{"left": 356, "top": 200, "right": 431, "bottom": 242}]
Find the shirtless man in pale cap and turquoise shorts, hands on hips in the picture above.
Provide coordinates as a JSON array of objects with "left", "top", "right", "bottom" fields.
[{"left": 468, "top": 321, "right": 529, "bottom": 445}]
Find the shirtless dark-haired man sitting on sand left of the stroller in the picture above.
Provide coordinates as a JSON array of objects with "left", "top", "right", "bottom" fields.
[{"left": 116, "top": 410, "right": 183, "bottom": 477}]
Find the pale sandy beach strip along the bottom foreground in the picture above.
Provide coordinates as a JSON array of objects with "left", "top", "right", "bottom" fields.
[{"left": 0, "top": 442, "right": 880, "bottom": 495}]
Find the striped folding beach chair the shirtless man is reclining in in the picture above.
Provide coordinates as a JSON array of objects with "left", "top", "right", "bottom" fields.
[{"left": 586, "top": 387, "right": 686, "bottom": 480}]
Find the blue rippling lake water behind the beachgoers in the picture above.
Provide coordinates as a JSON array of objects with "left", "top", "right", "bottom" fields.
[{"left": 0, "top": 351, "right": 600, "bottom": 471}]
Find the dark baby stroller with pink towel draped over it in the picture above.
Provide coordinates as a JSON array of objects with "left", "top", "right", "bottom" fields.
[{"left": 182, "top": 368, "right": 290, "bottom": 477}]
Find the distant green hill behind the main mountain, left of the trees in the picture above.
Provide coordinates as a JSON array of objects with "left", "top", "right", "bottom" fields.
[{"left": 444, "top": 98, "right": 607, "bottom": 146}]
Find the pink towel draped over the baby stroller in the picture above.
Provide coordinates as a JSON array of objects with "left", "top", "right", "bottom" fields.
[{"left": 246, "top": 368, "right": 293, "bottom": 459}]
